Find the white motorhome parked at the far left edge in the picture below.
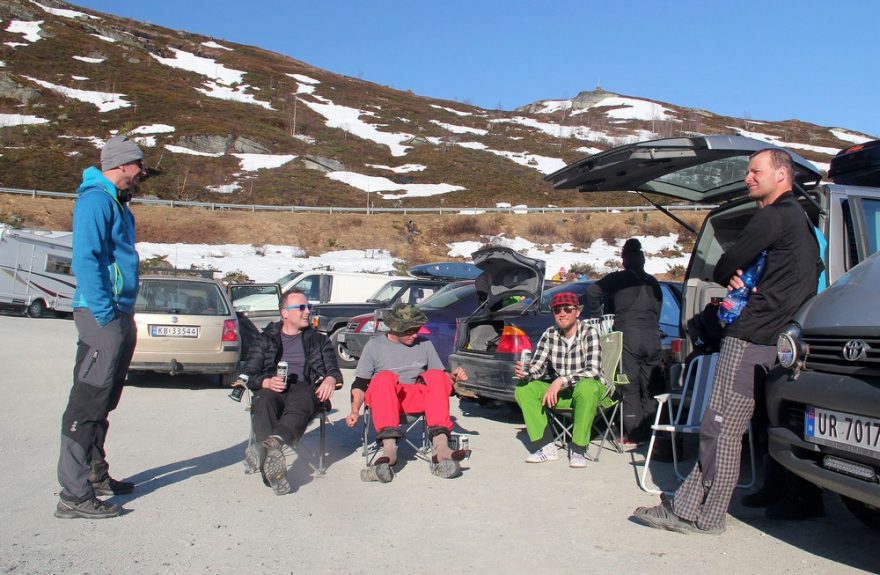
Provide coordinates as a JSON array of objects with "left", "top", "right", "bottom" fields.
[{"left": 0, "top": 227, "right": 76, "bottom": 317}]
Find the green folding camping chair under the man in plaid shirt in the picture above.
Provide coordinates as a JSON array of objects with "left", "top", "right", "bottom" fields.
[{"left": 547, "top": 331, "right": 629, "bottom": 461}]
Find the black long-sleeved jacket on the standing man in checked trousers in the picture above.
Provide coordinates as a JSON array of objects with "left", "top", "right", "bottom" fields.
[{"left": 714, "top": 192, "right": 820, "bottom": 345}]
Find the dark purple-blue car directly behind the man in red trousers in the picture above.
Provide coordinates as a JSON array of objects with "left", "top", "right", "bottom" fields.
[{"left": 337, "top": 280, "right": 480, "bottom": 367}]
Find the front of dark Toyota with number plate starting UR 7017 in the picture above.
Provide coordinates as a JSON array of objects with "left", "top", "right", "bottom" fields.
[{"left": 767, "top": 250, "right": 880, "bottom": 529}]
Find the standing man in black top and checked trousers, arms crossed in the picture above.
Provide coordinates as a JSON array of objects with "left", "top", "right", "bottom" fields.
[{"left": 633, "top": 148, "right": 819, "bottom": 534}]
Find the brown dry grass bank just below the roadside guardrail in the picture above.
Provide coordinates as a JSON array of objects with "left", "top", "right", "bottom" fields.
[{"left": 0, "top": 194, "right": 704, "bottom": 279}]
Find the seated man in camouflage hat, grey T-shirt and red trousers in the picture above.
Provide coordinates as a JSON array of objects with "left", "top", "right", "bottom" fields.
[{"left": 345, "top": 304, "right": 469, "bottom": 483}]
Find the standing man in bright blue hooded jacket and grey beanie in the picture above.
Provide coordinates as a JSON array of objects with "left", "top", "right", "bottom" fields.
[{"left": 55, "top": 136, "right": 146, "bottom": 519}]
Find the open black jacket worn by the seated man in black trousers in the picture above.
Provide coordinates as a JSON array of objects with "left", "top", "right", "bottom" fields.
[{"left": 242, "top": 321, "right": 342, "bottom": 391}]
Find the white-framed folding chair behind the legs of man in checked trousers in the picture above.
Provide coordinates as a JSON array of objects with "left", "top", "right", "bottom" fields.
[{"left": 636, "top": 353, "right": 755, "bottom": 494}]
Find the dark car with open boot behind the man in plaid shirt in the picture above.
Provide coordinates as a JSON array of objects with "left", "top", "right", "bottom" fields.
[{"left": 449, "top": 281, "right": 681, "bottom": 401}]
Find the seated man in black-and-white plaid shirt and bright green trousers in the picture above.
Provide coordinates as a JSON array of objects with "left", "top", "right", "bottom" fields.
[{"left": 514, "top": 292, "right": 606, "bottom": 468}]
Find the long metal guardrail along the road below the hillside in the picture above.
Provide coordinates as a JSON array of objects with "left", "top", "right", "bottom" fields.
[{"left": 0, "top": 188, "right": 715, "bottom": 215}]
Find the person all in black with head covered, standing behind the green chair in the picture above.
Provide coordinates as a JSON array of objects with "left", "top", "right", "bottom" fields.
[{"left": 587, "top": 238, "right": 663, "bottom": 443}]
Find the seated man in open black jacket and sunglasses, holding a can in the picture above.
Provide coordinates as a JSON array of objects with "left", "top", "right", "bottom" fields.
[{"left": 242, "top": 290, "right": 342, "bottom": 495}]
